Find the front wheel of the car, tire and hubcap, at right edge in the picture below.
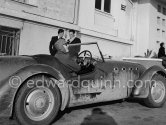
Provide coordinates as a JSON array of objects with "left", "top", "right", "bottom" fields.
[{"left": 144, "top": 74, "right": 166, "bottom": 108}]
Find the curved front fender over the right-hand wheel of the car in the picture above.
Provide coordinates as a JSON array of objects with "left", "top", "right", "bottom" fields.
[{"left": 133, "top": 66, "right": 166, "bottom": 98}]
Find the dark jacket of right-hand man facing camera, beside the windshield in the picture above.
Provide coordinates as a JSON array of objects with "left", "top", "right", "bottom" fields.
[{"left": 68, "top": 37, "right": 81, "bottom": 57}]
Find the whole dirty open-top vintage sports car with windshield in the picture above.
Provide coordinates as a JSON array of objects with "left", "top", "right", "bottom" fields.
[{"left": 0, "top": 42, "right": 166, "bottom": 125}]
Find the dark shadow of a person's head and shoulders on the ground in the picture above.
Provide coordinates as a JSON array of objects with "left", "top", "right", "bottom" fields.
[{"left": 81, "top": 108, "right": 118, "bottom": 125}]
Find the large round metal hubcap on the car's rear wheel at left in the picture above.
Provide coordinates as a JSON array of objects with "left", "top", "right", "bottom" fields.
[{"left": 24, "top": 87, "right": 55, "bottom": 121}]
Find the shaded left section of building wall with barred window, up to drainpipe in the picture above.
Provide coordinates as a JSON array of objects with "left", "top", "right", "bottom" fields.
[{"left": 0, "top": 0, "right": 79, "bottom": 55}]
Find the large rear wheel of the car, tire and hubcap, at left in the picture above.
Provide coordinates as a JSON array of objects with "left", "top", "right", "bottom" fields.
[{"left": 14, "top": 75, "right": 61, "bottom": 125}]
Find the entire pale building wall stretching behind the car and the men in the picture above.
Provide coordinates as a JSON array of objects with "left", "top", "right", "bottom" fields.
[{"left": 0, "top": 0, "right": 166, "bottom": 58}]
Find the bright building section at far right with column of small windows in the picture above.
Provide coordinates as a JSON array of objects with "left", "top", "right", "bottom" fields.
[{"left": 134, "top": 0, "right": 166, "bottom": 55}]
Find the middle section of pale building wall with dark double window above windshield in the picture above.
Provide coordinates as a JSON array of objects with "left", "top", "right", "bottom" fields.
[{"left": 78, "top": 0, "right": 134, "bottom": 57}]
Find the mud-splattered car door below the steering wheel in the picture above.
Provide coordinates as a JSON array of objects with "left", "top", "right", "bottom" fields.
[{"left": 69, "top": 64, "right": 105, "bottom": 107}]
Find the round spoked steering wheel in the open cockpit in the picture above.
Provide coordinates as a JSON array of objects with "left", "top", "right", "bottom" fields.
[{"left": 78, "top": 50, "right": 92, "bottom": 67}]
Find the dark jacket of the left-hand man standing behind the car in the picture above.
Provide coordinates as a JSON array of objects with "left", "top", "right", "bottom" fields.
[{"left": 49, "top": 36, "right": 58, "bottom": 56}]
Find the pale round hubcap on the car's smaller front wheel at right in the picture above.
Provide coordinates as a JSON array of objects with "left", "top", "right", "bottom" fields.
[{"left": 151, "top": 81, "right": 165, "bottom": 103}]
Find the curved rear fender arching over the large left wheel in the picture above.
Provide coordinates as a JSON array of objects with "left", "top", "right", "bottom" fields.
[{"left": 0, "top": 64, "right": 69, "bottom": 116}]
